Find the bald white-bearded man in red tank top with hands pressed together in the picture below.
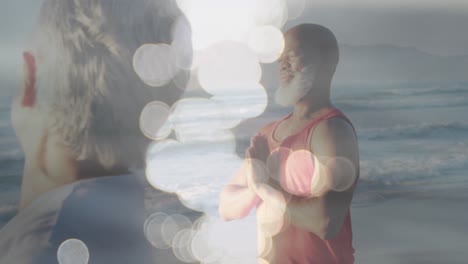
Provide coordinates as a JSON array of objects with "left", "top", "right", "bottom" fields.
[{"left": 219, "top": 24, "right": 359, "bottom": 264}]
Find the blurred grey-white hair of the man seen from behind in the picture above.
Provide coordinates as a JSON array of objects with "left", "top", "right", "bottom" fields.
[{"left": 30, "top": 0, "right": 190, "bottom": 168}]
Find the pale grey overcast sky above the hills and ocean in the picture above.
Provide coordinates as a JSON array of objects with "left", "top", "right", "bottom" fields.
[{"left": 0, "top": 0, "right": 468, "bottom": 87}]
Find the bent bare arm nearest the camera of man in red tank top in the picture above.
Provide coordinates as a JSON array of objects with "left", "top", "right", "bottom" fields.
[{"left": 259, "top": 118, "right": 359, "bottom": 239}]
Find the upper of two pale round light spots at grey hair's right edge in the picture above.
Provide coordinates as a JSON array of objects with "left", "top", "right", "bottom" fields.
[{"left": 133, "top": 44, "right": 178, "bottom": 87}]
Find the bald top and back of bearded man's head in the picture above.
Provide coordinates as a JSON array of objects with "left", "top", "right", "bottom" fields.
[{"left": 286, "top": 24, "right": 339, "bottom": 73}]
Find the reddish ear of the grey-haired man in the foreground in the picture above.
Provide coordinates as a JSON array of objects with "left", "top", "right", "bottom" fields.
[{"left": 19, "top": 52, "right": 37, "bottom": 107}]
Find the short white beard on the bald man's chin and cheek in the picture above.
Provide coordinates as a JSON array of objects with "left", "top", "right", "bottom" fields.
[{"left": 275, "top": 67, "right": 315, "bottom": 107}]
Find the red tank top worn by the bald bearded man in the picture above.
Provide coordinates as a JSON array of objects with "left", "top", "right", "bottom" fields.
[{"left": 260, "top": 108, "right": 354, "bottom": 264}]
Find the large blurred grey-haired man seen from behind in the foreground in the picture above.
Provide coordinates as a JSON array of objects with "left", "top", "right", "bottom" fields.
[{"left": 0, "top": 0, "right": 200, "bottom": 264}]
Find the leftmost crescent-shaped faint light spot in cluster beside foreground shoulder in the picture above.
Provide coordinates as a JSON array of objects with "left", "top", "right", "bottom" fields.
[{"left": 144, "top": 212, "right": 171, "bottom": 249}]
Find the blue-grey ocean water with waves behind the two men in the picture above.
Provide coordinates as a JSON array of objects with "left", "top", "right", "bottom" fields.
[{"left": 0, "top": 82, "right": 468, "bottom": 227}]
